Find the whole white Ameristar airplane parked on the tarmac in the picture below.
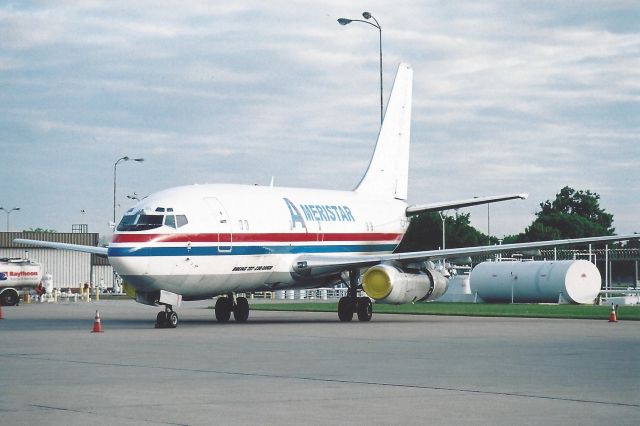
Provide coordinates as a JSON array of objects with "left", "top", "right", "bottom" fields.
[{"left": 15, "top": 64, "right": 638, "bottom": 327}]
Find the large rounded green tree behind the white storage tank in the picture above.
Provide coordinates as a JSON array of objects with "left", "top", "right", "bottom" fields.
[{"left": 505, "top": 186, "right": 615, "bottom": 243}]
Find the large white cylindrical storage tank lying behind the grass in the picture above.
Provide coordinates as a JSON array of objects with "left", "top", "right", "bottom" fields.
[{"left": 470, "top": 260, "right": 602, "bottom": 304}]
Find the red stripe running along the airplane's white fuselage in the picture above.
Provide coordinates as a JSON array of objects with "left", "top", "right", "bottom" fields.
[{"left": 111, "top": 232, "right": 403, "bottom": 243}]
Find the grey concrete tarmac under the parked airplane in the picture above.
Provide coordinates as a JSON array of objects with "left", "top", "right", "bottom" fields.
[{"left": 0, "top": 301, "right": 640, "bottom": 425}]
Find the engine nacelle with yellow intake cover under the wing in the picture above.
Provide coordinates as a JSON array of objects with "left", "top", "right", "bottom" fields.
[{"left": 362, "top": 265, "right": 449, "bottom": 305}]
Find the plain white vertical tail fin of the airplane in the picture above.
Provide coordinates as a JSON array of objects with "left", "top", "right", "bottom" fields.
[{"left": 356, "top": 63, "right": 413, "bottom": 200}]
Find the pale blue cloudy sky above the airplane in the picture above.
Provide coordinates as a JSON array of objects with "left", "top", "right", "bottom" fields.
[{"left": 0, "top": 0, "right": 640, "bottom": 237}]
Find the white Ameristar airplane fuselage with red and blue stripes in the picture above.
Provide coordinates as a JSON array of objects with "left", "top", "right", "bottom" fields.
[{"left": 108, "top": 184, "right": 408, "bottom": 300}]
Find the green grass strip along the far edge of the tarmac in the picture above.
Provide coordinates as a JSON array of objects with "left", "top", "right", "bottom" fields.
[{"left": 251, "top": 302, "right": 640, "bottom": 321}]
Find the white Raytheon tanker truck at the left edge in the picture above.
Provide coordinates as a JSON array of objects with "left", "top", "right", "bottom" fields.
[{"left": 0, "top": 258, "right": 42, "bottom": 306}]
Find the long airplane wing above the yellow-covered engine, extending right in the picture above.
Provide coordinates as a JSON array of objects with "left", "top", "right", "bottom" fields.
[{"left": 293, "top": 234, "right": 640, "bottom": 276}]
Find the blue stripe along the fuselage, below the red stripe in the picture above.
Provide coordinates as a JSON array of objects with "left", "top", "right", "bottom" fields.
[{"left": 108, "top": 244, "right": 397, "bottom": 257}]
